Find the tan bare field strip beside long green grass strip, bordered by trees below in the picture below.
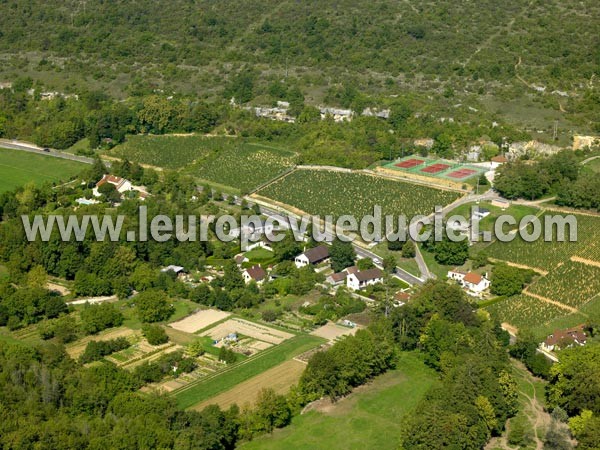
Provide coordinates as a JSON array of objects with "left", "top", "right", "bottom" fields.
[{"left": 193, "top": 359, "right": 306, "bottom": 410}]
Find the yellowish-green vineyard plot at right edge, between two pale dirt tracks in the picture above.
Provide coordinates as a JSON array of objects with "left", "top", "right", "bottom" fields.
[{"left": 528, "top": 261, "right": 600, "bottom": 308}]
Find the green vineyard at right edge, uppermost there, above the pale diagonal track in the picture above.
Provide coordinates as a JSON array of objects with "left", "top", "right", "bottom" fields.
[{"left": 486, "top": 213, "right": 600, "bottom": 271}]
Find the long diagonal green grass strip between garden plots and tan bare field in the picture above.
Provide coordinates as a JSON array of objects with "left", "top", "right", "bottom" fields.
[{"left": 173, "top": 334, "right": 325, "bottom": 408}]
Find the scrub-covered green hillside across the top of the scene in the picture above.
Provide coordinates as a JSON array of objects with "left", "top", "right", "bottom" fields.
[{"left": 0, "top": 0, "right": 600, "bottom": 132}]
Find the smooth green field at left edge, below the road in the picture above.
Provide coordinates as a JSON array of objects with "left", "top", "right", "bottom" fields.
[{"left": 0, "top": 148, "right": 86, "bottom": 192}]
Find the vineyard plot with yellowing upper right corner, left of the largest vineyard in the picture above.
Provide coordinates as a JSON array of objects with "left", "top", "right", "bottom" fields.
[{"left": 186, "top": 139, "right": 296, "bottom": 192}]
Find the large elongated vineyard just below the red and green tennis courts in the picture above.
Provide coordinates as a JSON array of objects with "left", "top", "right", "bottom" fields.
[{"left": 258, "top": 170, "right": 460, "bottom": 219}]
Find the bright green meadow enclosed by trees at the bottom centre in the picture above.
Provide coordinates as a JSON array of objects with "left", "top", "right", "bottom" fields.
[{"left": 241, "top": 353, "right": 436, "bottom": 450}]
